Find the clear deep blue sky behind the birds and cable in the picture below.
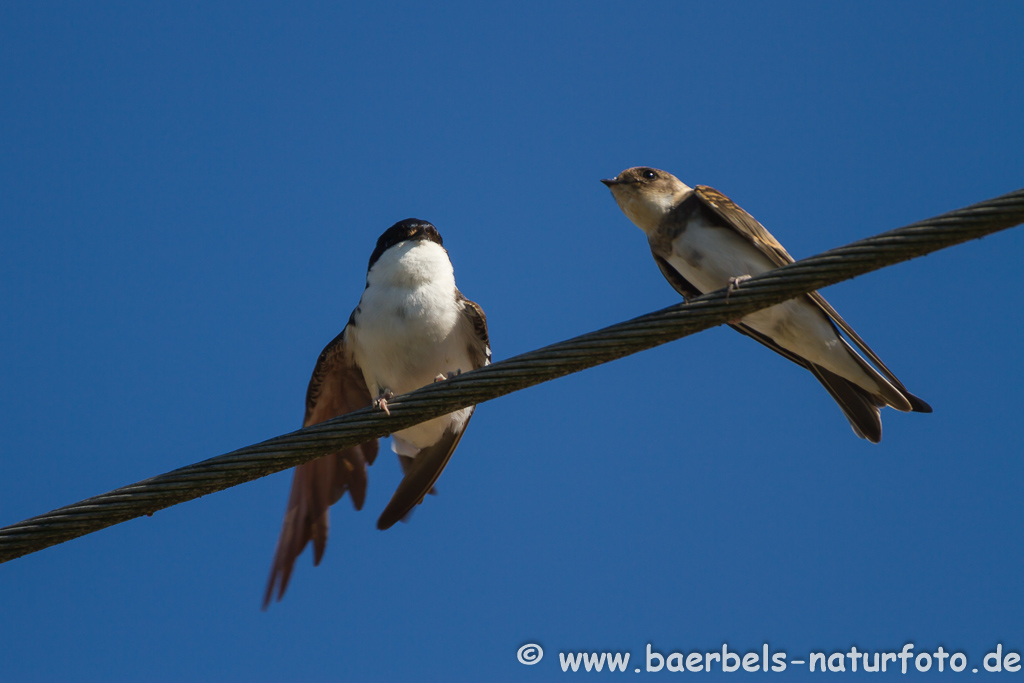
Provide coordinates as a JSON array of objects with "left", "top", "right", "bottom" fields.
[{"left": 0, "top": 2, "right": 1024, "bottom": 681}]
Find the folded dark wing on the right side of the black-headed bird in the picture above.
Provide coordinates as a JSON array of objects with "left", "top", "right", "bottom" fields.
[{"left": 377, "top": 290, "right": 490, "bottom": 529}]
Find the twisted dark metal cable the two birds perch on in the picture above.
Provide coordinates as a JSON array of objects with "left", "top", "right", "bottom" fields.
[{"left": 0, "top": 189, "right": 1024, "bottom": 562}]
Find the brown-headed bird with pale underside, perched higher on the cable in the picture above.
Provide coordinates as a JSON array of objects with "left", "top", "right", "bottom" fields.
[{"left": 601, "top": 167, "right": 932, "bottom": 443}]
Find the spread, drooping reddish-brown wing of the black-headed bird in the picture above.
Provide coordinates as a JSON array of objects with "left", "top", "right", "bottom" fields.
[{"left": 263, "top": 328, "right": 377, "bottom": 609}]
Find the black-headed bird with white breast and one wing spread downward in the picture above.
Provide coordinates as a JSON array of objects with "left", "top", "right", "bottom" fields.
[{"left": 263, "top": 218, "right": 490, "bottom": 608}]
